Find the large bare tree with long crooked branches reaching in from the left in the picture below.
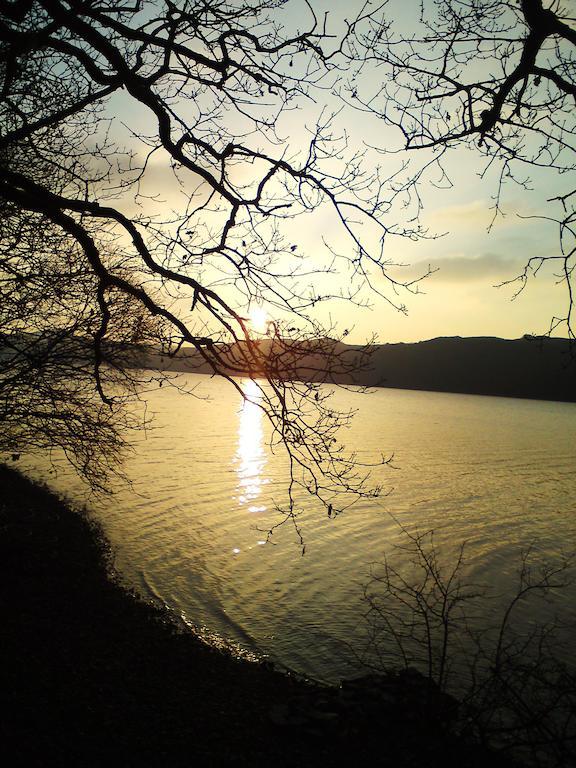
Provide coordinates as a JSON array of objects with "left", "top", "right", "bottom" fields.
[{"left": 0, "top": 0, "right": 415, "bottom": 522}]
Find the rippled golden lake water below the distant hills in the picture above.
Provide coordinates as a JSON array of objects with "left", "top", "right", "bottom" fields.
[{"left": 21, "top": 375, "right": 576, "bottom": 680}]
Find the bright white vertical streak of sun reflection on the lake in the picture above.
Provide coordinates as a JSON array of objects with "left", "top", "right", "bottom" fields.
[{"left": 236, "top": 379, "right": 268, "bottom": 513}]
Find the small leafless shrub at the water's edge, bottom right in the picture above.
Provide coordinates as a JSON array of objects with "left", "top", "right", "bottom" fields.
[{"left": 361, "top": 526, "right": 576, "bottom": 766}]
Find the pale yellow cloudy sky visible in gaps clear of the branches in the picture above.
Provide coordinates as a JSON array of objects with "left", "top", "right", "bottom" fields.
[{"left": 104, "top": 1, "right": 564, "bottom": 343}]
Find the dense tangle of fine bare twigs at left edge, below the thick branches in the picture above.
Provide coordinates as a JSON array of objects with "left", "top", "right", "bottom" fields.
[{"left": 0, "top": 192, "right": 158, "bottom": 489}]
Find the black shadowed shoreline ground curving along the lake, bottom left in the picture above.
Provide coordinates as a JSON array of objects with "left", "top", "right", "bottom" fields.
[{"left": 0, "top": 466, "right": 507, "bottom": 767}]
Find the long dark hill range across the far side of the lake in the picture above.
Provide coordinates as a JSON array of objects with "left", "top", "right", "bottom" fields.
[{"left": 0, "top": 334, "right": 576, "bottom": 402}]
